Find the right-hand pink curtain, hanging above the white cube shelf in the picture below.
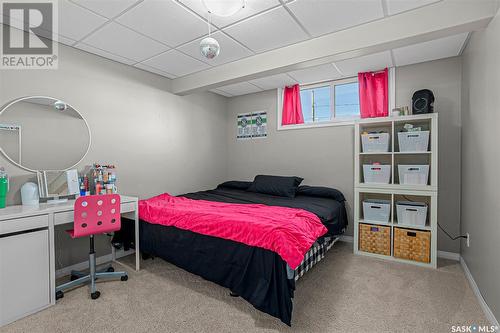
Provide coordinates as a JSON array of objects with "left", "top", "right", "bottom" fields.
[{"left": 358, "top": 68, "right": 389, "bottom": 118}]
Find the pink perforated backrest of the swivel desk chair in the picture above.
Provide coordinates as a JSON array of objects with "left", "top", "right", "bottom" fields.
[{"left": 71, "top": 194, "right": 121, "bottom": 238}]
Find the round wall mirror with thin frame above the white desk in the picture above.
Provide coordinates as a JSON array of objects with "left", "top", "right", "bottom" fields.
[{"left": 0, "top": 96, "right": 91, "bottom": 172}]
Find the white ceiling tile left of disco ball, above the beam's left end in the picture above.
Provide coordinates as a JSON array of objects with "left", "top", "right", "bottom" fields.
[{"left": 143, "top": 50, "right": 210, "bottom": 76}]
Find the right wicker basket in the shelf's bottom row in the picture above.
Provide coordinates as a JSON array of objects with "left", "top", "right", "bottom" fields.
[{"left": 394, "top": 228, "right": 431, "bottom": 263}]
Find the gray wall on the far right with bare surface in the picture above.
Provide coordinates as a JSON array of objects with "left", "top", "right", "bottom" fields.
[{"left": 462, "top": 14, "right": 500, "bottom": 319}]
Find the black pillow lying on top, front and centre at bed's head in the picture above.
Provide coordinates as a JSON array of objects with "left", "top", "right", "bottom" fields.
[{"left": 248, "top": 175, "right": 304, "bottom": 198}]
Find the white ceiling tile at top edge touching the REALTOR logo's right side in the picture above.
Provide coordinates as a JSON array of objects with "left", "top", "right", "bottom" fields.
[{"left": 58, "top": 0, "right": 107, "bottom": 40}]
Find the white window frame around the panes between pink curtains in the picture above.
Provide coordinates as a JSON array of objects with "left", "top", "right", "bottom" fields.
[{"left": 276, "top": 67, "right": 396, "bottom": 131}]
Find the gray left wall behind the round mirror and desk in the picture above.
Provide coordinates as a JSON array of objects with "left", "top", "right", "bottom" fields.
[{"left": 0, "top": 45, "right": 227, "bottom": 267}]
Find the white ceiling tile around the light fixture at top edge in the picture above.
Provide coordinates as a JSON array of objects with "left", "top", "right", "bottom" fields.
[{"left": 180, "top": 0, "right": 280, "bottom": 28}]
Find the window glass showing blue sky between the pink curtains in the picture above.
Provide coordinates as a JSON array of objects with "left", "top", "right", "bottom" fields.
[{"left": 300, "top": 79, "right": 359, "bottom": 124}]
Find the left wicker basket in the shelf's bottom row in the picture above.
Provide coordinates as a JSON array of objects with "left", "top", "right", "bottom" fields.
[{"left": 359, "top": 223, "right": 391, "bottom": 256}]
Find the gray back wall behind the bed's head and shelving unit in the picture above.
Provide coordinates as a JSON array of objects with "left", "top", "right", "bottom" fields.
[{"left": 227, "top": 58, "right": 461, "bottom": 252}]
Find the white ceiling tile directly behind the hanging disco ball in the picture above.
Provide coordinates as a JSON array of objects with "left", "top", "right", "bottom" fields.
[{"left": 178, "top": 31, "right": 253, "bottom": 66}]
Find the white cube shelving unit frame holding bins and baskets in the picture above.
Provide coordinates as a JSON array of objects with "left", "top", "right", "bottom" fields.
[{"left": 354, "top": 113, "right": 438, "bottom": 268}]
